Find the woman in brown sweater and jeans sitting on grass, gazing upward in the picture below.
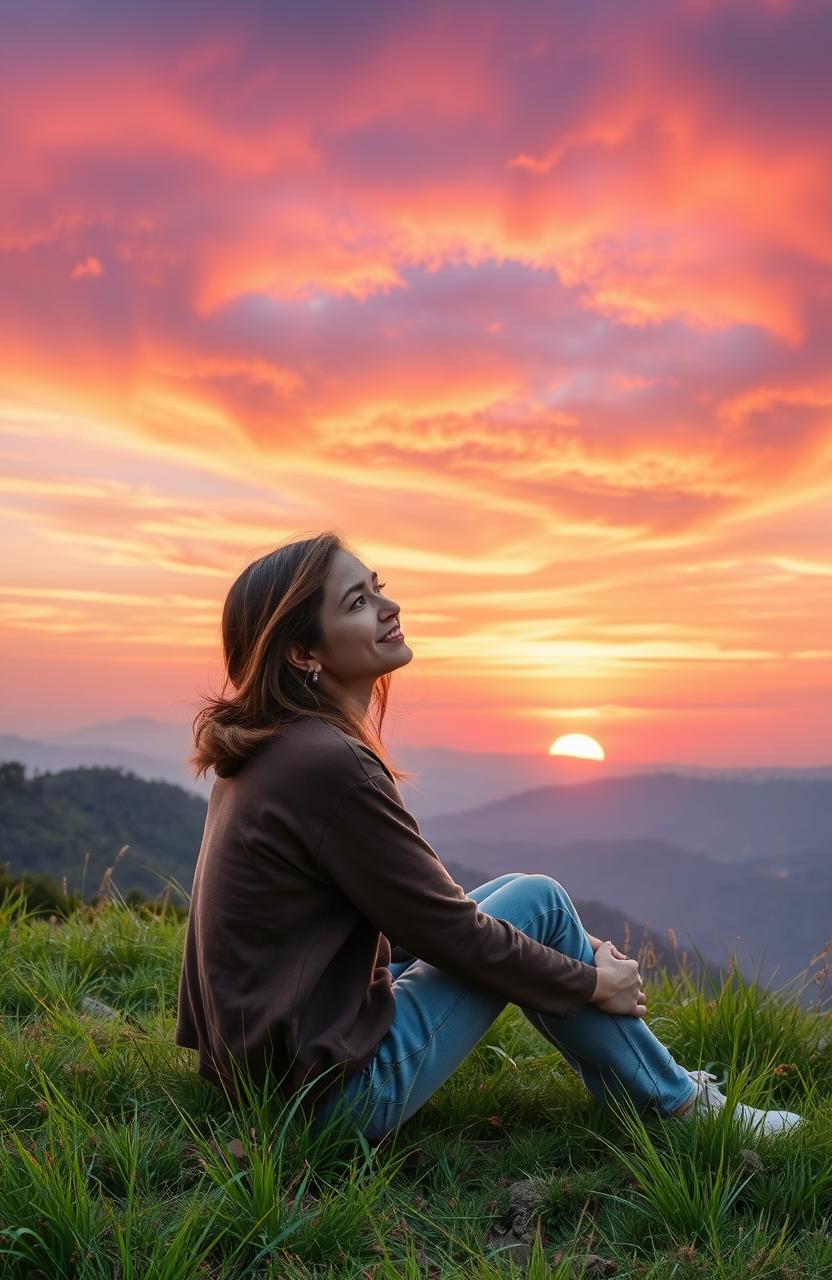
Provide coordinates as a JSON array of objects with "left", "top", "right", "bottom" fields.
[{"left": 175, "top": 532, "right": 800, "bottom": 1142}]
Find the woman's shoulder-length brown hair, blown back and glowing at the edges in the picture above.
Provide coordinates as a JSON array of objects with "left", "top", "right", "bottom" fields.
[{"left": 188, "top": 531, "right": 412, "bottom": 780}]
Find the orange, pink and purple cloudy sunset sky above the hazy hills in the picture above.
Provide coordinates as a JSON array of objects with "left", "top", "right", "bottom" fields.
[{"left": 0, "top": 0, "right": 832, "bottom": 765}]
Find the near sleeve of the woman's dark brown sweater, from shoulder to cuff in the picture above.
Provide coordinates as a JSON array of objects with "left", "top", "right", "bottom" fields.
[{"left": 317, "top": 774, "right": 598, "bottom": 1018}]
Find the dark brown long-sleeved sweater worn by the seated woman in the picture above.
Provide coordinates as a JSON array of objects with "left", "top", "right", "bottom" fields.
[{"left": 174, "top": 718, "right": 598, "bottom": 1111}]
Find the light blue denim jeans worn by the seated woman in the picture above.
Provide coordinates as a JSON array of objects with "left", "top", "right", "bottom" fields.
[{"left": 311, "top": 872, "right": 695, "bottom": 1142}]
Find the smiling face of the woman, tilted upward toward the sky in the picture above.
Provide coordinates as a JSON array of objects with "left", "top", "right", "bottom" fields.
[{"left": 300, "top": 549, "right": 413, "bottom": 701}]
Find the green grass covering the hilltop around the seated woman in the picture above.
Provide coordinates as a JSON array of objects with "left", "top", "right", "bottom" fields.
[{"left": 0, "top": 880, "right": 832, "bottom": 1280}]
